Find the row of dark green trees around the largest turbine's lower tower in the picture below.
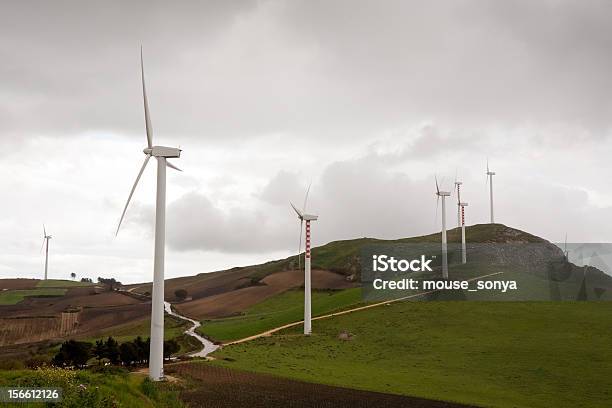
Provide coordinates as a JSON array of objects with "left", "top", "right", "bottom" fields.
[{"left": 52, "top": 336, "right": 180, "bottom": 368}]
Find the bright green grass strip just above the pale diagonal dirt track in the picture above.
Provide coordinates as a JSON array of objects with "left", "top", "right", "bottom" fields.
[{"left": 198, "top": 288, "right": 361, "bottom": 341}]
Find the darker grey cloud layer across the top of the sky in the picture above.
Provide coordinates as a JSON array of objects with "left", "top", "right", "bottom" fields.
[{"left": 0, "top": 0, "right": 612, "bottom": 143}]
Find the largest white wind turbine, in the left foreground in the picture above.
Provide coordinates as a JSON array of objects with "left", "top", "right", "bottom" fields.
[{"left": 115, "top": 48, "right": 181, "bottom": 381}]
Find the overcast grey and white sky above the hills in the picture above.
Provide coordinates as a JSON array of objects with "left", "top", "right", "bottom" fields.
[{"left": 0, "top": 0, "right": 612, "bottom": 282}]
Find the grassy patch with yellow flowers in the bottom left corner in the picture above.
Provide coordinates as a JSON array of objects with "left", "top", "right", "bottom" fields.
[{"left": 0, "top": 368, "right": 183, "bottom": 408}]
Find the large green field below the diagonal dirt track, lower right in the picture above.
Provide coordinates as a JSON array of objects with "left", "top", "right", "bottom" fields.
[{"left": 213, "top": 302, "right": 612, "bottom": 407}]
